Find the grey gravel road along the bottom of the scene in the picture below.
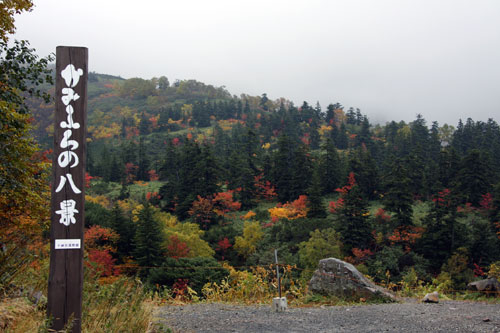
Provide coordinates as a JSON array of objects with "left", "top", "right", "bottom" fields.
[{"left": 157, "top": 301, "right": 500, "bottom": 333}]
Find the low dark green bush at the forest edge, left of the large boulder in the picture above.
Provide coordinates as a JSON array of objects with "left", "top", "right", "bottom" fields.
[{"left": 147, "top": 258, "right": 229, "bottom": 295}]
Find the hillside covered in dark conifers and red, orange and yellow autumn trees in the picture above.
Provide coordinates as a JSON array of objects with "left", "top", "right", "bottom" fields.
[{"left": 26, "top": 73, "right": 500, "bottom": 290}]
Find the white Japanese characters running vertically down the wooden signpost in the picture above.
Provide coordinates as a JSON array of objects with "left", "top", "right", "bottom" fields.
[{"left": 55, "top": 64, "right": 83, "bottom": 227}]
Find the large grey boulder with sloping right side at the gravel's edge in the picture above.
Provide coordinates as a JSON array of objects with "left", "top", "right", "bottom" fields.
[{"left": 309, "top": 258, "right": 395, "bottom": 301}]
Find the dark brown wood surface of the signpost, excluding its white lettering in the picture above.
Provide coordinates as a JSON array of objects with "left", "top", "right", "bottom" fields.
[{"left": 47, "top": 46, "right": 88, "bottom": 332}]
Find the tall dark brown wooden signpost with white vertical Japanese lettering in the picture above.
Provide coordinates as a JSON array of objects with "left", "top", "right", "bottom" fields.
[{"left": 47, "top": 46, "right": 88, "bottom": 332}]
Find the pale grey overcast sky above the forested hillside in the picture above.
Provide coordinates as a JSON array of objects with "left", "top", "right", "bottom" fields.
[{"left": 14, "top": 0, "right": 500, "bottom": 125}]
